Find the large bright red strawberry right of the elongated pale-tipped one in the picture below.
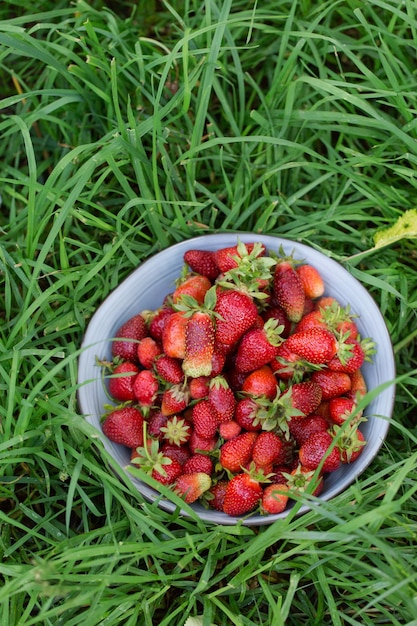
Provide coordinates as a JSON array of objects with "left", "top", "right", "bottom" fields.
[{"left": 214, "top": 289, "right": 258, "bottom": 351}]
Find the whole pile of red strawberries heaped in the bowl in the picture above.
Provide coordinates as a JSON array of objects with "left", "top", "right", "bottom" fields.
[{"left": 100, "top": 242, "right": 374, "bottom": 516}]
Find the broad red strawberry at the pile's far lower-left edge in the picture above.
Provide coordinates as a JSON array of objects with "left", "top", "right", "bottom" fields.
[{"left": 102, "top": 406, "right": 144, "bottom": 448}]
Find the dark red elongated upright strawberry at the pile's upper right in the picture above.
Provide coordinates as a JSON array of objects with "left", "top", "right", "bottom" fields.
[{"left": 273, "top": 261, "right": 305, "bottom": 322}]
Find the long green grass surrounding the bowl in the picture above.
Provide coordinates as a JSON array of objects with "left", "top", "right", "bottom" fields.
[{"left": 0, "top": 0, "right": 417, "bottom": 626}]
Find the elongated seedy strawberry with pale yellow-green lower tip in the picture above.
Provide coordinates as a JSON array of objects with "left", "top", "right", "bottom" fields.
[{"left": 182, "top": 311, "right": 215, "bottom": 378}]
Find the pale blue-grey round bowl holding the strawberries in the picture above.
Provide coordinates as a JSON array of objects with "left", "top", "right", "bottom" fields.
[{"left": 78, "top": 233, "right": 395, "bottom": 525}]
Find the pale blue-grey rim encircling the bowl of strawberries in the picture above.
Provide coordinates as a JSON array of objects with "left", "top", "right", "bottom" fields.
[{"left": 77, "top": 231, "right": 396, "bottom": 526}]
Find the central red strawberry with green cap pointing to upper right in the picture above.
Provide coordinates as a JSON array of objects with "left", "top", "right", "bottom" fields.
[{"left": 235, "top": 319, "right": 283, "bottom": 372}]
